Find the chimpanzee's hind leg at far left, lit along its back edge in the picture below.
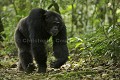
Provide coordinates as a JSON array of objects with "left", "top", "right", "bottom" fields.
[{"left": 15, "top": 30, "right": 35, "bottom": 73}]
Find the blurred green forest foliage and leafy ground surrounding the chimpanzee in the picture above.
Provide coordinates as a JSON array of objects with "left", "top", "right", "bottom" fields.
[{"left": 0, "top": 0, "right": 120, "bottom": 80}]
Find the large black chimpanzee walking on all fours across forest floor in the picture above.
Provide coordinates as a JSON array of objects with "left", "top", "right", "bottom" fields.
[{"left": 15, "top": 8, "right": 68, "bottom": 73}]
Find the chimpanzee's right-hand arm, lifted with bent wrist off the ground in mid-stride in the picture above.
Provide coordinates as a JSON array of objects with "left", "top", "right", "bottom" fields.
[{"left": 51, "top": 26, "right": 68, "bottom": 68}]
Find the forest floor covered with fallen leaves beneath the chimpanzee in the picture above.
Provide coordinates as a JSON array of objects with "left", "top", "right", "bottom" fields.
[{"left": 0, "top": 55, "right": 120, "bottom": 80}]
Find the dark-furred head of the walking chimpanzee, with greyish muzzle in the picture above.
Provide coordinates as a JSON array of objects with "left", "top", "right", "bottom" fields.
[{"left": 45, "top": 11, "right": 64, "bottom": 36}]
